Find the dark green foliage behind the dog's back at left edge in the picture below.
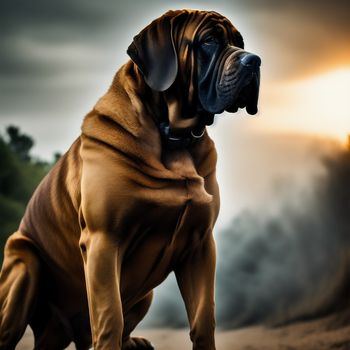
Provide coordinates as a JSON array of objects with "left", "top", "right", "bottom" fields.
[{"left": 0, "top": 126, "right": 51, "bottom": 262}]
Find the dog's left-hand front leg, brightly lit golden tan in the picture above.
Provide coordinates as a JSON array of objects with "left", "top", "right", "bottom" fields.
[{"left": 80, "top": 230, "right": 123, "bottom": 350}]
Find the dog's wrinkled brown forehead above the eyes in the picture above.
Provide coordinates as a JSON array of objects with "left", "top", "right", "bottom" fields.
[{"left": 173, "top": 10, "right": 243, "bottom": 46}]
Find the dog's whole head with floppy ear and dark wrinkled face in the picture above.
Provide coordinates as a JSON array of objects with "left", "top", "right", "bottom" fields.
[{"left": 128, "top": 10, "right": 260, "bottom": 129}]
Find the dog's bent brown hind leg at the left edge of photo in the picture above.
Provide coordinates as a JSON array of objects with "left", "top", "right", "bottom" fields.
[{"left": 0, "top": 232, "right": 40, "bottom": 350}]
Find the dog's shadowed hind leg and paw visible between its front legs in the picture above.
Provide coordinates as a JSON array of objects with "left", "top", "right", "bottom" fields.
[{"left": 122, "top": 291, "right": 154, "bottom": 350}]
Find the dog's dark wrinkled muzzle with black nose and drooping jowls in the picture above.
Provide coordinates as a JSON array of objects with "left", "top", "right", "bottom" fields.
[{"left": 217, "top": 51, "right": 261, "bottom": 115}]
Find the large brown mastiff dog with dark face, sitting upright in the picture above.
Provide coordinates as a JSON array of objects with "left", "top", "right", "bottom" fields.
[{"left": 0, "top": 10, "right": 260, "bottom": 350}]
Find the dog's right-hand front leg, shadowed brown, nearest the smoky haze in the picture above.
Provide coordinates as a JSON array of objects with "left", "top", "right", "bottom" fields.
[{"left": 175, "top": 234, "right": 216, "bottom": 350}]
